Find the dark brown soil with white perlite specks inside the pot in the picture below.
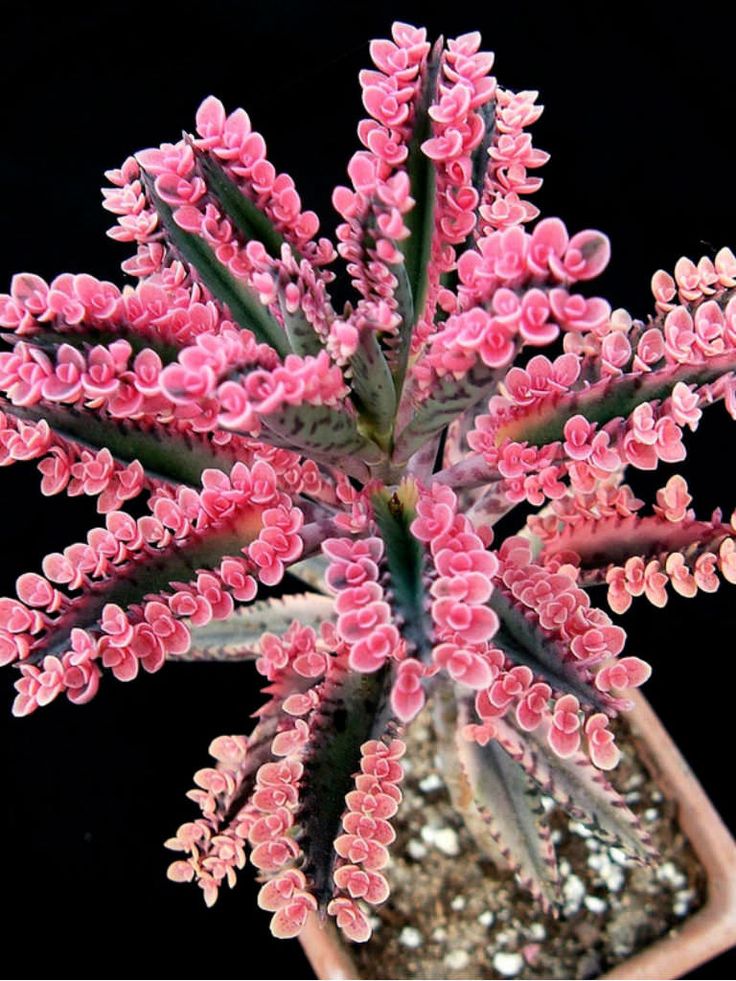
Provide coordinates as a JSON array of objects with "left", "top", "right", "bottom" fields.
[{"left": 352, "top": 720, "right": 704, "bottom": 979}]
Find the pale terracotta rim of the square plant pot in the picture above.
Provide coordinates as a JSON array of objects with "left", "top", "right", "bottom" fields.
[{"left": 300, "top": 692, "right": 736, "bottom": 981}]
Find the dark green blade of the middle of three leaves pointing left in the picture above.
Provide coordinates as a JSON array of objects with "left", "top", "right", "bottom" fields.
[{"left": 0, "top": 399, "right": 236, "bottom": 487}]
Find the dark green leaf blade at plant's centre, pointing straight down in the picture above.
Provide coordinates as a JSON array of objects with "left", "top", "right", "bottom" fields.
[{"left": 371, "top": 482, "right": 432, "bottom": 661}]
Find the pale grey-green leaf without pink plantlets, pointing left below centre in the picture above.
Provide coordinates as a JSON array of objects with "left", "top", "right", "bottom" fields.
[{"left": 171, "top": 593, "right": 334, "bottom": 661}]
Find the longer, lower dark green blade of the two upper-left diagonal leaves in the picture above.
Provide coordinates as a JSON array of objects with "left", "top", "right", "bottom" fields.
[{"left": 141, "top": 171, "right": 290, "bottom": 357}]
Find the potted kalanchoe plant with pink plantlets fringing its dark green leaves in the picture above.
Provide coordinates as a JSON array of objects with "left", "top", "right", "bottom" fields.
[{"left": 0, "top": 23, "right": 736, "bottom": 940}]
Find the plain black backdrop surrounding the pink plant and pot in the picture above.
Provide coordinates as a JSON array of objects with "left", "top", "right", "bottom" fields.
[{"left": 0, "top": 2, "right": 736, "bottom": 978}]
